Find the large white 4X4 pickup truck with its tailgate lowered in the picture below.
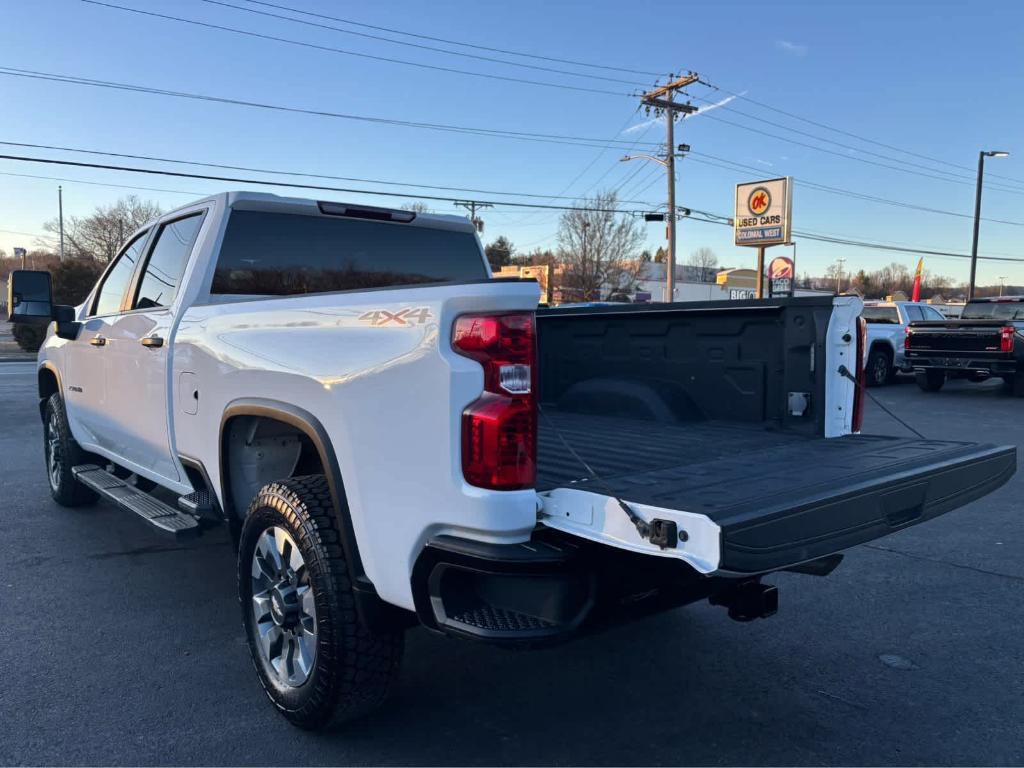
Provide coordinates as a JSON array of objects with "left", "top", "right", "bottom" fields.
[{"left": 9, "top": 193, "right": 1017, "bottom": 727}]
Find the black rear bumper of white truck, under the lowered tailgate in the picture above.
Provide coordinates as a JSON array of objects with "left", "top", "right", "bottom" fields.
[{"left": 413, "top": 528, "right": 735, "bottom": 646}]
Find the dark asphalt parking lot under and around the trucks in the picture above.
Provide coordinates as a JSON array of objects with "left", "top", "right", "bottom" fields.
[{"left": 0, "top": 362, "right": 1024, "bottom": 765}]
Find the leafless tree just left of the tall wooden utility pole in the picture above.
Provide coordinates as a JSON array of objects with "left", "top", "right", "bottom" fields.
[{"left": 557, "top": 191, "right": 644, "bottom": 301}]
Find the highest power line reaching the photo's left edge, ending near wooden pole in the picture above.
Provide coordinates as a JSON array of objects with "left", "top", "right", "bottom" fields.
[{"left": 0, "top": 66, "right": 655, "bottom": 148}]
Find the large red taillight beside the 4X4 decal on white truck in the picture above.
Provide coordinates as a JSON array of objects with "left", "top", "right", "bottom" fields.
[{"left": 452, "top": 312, "right": 537, "bottom": 490}]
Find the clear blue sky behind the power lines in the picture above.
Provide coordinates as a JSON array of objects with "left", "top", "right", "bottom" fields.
[{"left": 0, "top": 0, "right": 1024, "bottom": 284}]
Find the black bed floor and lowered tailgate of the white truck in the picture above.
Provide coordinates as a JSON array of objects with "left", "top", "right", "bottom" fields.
[{"left": 538, "top": 410, "right": 1017, "bottom": 573}]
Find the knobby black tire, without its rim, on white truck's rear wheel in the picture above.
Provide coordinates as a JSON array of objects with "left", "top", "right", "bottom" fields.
[{"left": 239, "top": 475, "right": 404, "bottom": 729}]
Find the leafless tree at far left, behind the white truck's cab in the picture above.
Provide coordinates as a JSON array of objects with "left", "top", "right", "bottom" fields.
[{"left": 43, "top": 195, "right": 163, "bottom": 262}]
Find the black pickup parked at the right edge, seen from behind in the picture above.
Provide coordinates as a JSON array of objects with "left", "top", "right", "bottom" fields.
[{"left": 904, "top": 296, "right": 1024, "bottom": 397}]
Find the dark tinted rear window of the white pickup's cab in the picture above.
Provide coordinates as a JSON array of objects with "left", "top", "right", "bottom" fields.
[{"left": 210, "top": 211, "right": 487, "bottom": 296}]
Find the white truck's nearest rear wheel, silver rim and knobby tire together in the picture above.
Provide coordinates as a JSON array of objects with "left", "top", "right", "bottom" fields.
[{"left": 239, "top": 475, "right": 403, "bottom": 729}]
